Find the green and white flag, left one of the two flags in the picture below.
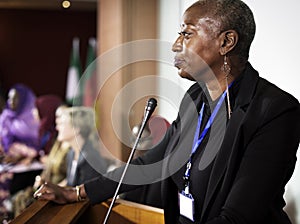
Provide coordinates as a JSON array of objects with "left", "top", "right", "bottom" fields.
[{"left": 66, "top": 37, "right": 81, "bottom": 106}]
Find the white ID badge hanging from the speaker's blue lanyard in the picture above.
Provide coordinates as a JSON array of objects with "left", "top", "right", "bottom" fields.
[{"left": 178, "top": 191, "right": 194, "bottom": 221}]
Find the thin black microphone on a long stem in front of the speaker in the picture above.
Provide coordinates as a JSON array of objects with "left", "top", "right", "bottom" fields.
[{"left": 103, "top": 98, "right": 157, "bottom": 224}]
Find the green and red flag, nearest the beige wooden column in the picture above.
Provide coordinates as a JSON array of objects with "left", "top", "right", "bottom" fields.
[{"left": 80, "top": 38, "right": 97, "bottom": 107}]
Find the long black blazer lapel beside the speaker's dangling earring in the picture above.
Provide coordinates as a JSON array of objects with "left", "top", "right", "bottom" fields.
[{"left": 201, "top": 63, "right": 259, "bottom": 217}]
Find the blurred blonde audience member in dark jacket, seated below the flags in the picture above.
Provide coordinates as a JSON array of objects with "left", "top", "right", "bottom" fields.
[{"left": 56, "top": 107, "right": 107, "bottom": 186}]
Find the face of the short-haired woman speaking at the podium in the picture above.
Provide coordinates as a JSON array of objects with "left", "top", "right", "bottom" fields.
[{"left": 172, "top": 6, "right": 221, "bottom": 81}]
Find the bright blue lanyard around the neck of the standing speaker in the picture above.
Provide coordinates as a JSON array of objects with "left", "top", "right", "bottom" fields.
[{"left": 184, "top": 86, "right": 232, "bottom": 180}]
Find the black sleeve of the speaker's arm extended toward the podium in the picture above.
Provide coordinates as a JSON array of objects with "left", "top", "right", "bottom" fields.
[{"left": 84, "top": 122, "right": 176, "bottom": 204}]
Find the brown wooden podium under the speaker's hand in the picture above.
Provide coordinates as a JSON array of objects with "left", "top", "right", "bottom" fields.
[{"left": 10, "top": 199, "right": 164, "bottom": 224}]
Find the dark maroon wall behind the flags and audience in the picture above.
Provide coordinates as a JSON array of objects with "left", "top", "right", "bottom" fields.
[{"left": 0, "top": 9, "right": 97, "bottom": 99}]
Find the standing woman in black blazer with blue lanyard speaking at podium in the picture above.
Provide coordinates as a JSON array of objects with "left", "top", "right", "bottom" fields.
[{"left": 35, "top": 0, "right": 300, "bottom": 224}]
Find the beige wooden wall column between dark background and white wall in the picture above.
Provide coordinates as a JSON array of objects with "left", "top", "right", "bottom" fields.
[{"left": 97, "top": 0, "right": 157, "bottom": 160}]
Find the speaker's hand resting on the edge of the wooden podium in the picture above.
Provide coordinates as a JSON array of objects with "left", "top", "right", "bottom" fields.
[{"left": 33, "top": 182, "right": 77, "bottom": 204}]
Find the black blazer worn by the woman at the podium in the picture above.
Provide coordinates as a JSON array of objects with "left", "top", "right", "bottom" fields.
[{"left": 85, "top": 64, "right": 300, "bottom": 224}]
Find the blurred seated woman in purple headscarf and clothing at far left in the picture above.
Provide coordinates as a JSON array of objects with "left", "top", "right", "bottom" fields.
[{"left": 0, "top": 84, "right": 39, "bottom": 163}]
